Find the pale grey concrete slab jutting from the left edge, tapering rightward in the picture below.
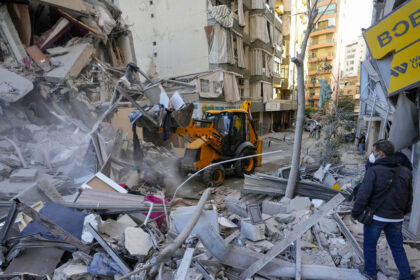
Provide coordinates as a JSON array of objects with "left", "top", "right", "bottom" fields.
[{"left": 0, "top": 67, "right": 34, "bottom": 103}]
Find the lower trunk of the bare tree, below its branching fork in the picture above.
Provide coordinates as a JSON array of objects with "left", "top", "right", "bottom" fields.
[{"left": 285, "top": 62, "right": 305, "bottom": 198}]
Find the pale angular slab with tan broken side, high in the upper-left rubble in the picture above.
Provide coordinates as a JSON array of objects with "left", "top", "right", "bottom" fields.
[{"left": 44, "top": 43, "right": 94, "bottom": 83}]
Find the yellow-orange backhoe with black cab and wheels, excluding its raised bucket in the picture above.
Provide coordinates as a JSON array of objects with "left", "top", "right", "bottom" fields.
[{"left": 176, "top": 101, "right": 262, "bottom": 186}]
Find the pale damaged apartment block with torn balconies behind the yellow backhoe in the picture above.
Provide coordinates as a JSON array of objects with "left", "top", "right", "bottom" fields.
[{"left": 116, "top": 0, "right": 305, "bottom": 134}]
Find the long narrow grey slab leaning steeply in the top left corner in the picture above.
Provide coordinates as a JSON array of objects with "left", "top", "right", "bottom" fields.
[{"left": 0, "top": 5, "right": 29, "bottom": 64}]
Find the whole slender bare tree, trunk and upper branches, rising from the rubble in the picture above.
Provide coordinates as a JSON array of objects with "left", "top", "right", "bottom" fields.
[{"left": 286, "top": 0, "right": 332, "bottom": 198}]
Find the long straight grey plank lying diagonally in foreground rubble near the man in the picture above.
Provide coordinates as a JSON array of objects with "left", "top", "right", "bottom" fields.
[{"left": 241, "top": 194, "right": 345, "bottom": 279}]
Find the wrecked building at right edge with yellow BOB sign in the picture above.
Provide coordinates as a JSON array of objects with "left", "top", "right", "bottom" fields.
[{"left": 357, "top": 0, "right": 420, "bottom": 240}]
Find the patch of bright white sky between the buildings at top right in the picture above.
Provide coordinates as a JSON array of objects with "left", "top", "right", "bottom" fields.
[{"left": 343, "top": 0, "right": 373, "bottom": 45}]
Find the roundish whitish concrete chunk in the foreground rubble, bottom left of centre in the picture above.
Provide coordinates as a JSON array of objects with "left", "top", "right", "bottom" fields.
[{"left": 124, "top": 227, "right": 153, "bottom": 257}]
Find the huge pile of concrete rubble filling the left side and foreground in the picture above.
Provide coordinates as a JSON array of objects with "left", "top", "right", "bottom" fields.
[{"left": 0, "top": 0, "right": 420, "bottom": 280}]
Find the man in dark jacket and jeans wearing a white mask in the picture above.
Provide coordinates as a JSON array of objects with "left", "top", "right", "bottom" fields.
[{"left": 352, "top": 140, "right": 413, "bottom": 280}]
